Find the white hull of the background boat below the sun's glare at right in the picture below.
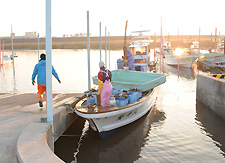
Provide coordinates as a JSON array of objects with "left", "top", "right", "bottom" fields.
[{"left": 165, "top": 56, "right": 197, "bottom": 68}]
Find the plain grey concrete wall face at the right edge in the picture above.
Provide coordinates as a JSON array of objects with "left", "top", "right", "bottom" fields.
[{"left": 196, "top": 75, "right": 225, "bottom": 119}]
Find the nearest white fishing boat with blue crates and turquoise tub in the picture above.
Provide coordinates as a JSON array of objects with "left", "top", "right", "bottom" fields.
[{"left": 74, "top": 70, "right": 166, "bottom": 138}]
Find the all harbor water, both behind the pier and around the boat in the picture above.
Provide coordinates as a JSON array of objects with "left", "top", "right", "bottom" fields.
[{"left": 0, "top": 50, "right": 225, "bottom": 163}]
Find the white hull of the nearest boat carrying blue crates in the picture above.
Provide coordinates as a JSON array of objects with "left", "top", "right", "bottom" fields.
[{"left": 75, "top": 88, "right": 156, "bottom": 138}]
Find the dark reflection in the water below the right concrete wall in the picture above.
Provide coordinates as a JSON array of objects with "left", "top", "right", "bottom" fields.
[{"left": 195, "top": 101, "right": 225, "bottom": 157}]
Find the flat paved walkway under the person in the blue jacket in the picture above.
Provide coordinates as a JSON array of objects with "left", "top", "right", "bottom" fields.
[{"left": 0, "top": 93, "right": 78, "bottom": 163}]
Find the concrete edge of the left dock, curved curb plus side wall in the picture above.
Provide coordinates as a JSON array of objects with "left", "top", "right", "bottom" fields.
[{"left": 16, "top": 104, "right": 77, "bottom": 163}]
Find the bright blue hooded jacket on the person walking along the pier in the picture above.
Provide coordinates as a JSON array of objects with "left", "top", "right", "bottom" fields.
[{"left": 32, "top": 60, "right": 59, "bottom": 85}]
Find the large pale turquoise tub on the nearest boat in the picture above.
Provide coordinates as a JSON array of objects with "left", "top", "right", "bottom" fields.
[{"left": 92, "top": 70, "right": 166, "bottom": 91}]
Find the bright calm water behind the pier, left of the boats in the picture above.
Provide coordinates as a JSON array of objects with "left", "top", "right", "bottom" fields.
[{"left": 0, "top": 50, "right": 123, "bottom": 92}]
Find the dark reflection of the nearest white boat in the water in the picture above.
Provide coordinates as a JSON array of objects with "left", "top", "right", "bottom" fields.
[{"left": 74, "top": 108, "right": 153, "bottom": 163}]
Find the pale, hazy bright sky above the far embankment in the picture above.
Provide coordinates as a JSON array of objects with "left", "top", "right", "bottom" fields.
[{"left": 0, "top": 0, "right": 225, "bottom": 37}]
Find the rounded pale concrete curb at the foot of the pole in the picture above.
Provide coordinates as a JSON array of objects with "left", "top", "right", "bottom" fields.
[{"left": 16, "top": 123, "right": 63, "bottom": 163}]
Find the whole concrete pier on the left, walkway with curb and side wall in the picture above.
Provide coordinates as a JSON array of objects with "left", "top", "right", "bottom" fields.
[{"left": 0, "top": 93, "right": 79, "bottom": 163}]
